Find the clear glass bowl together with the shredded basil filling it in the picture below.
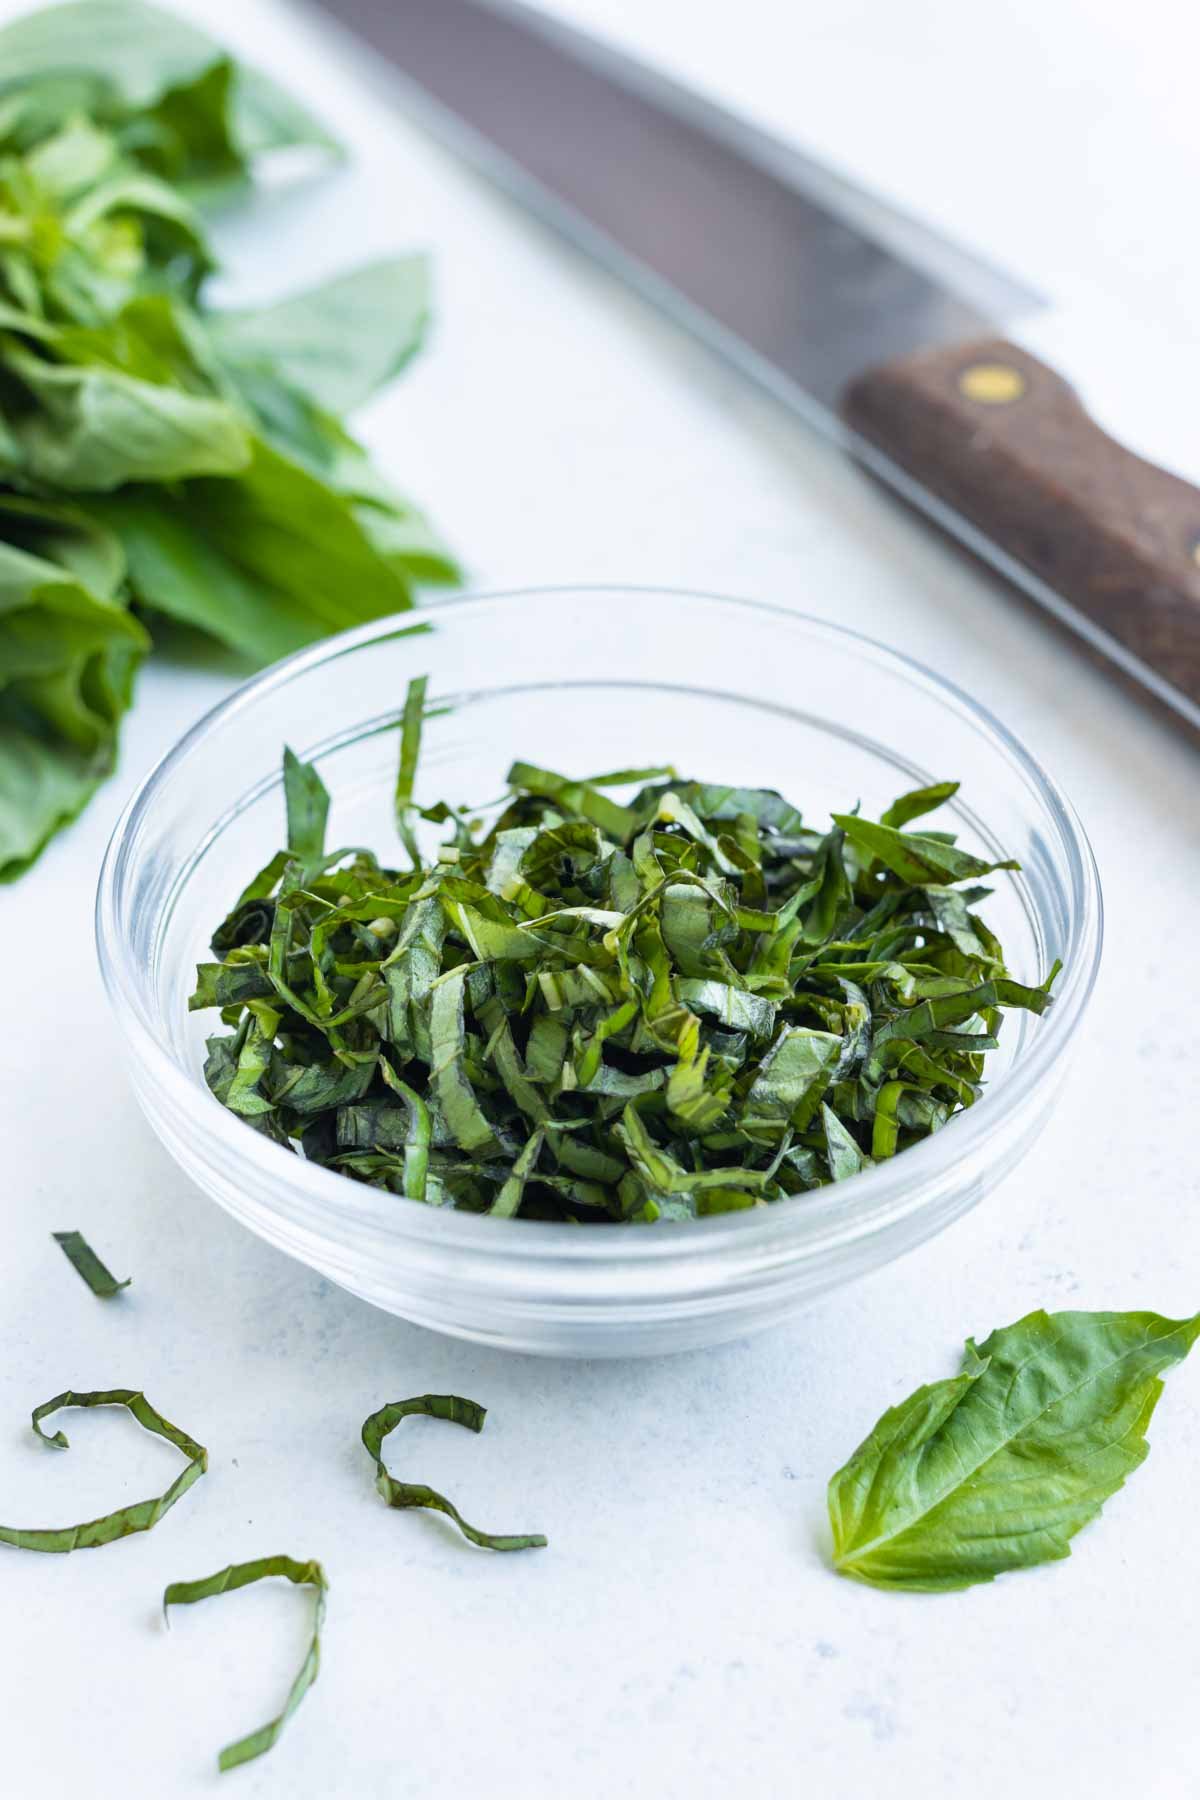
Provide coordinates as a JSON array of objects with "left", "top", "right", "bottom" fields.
[{"left": 97, "top": 589, "right": 1101, "bottom": 1355}]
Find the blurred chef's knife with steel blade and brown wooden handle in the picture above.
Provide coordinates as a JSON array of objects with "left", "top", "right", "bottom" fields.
[{"left": 313, "top": 0, "right": 1200, "bottom": 729}]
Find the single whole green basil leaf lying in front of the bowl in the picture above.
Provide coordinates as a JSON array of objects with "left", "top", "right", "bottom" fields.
[{"left": 829, "top": 1312, "right": 1200, "bottom": 1593}]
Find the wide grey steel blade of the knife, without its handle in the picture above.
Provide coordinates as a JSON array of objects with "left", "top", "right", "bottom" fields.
[{"left": 309, "top": 0, "right": 1038, "bottom": 412}]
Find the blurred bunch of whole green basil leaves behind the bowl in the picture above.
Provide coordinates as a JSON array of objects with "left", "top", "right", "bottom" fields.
[{"left": 0, "top": 0, "right": 455, "bottom": 880}]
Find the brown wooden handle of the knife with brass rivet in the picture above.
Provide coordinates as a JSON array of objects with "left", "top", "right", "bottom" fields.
[{"left": 842, "top": 340, "right": 1200, "bottom": 704}]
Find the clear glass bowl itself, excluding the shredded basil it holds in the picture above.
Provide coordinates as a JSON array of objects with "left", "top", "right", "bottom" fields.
[{"left": 97, "top": 587, "right": 1101, "bottom": 1355}]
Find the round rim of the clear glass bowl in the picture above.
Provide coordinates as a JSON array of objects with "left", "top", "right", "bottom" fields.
[{"left": 95, "top": 581, "right": 1103, "bottom": 1271}]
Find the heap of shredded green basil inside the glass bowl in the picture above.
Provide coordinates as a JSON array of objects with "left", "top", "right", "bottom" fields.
[{"left": 191, "top": 680, "right": 1058, "bottom": 1222}]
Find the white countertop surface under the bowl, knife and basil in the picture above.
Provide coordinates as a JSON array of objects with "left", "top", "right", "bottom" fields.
[{"left": 0, "top": 0, "right": 1200, "bottom": 1800}]
